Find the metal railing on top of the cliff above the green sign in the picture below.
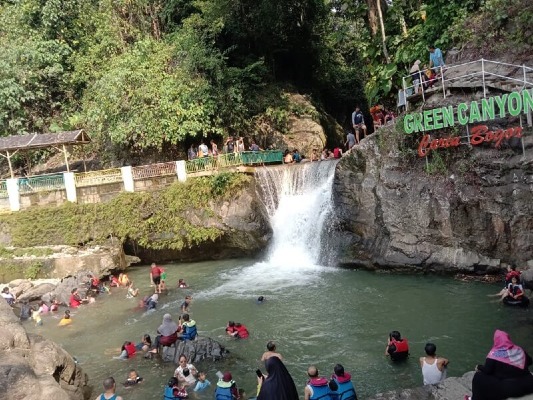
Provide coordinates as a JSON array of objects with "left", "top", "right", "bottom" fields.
[{"left": 402, "top": 58, "right": 533, "bottom": 111}]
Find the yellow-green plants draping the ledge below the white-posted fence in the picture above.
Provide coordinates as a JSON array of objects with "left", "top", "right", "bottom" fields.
[{"left": 0, "top": 174, "right": 249, "bottom": 250}]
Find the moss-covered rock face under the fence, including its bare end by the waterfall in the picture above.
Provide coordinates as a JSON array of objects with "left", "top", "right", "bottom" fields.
[{"left": 0, "top": 173, "right": 269, "bottom": 261}]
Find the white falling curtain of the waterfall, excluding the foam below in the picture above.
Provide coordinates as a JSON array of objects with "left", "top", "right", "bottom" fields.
[{"left": 255, "top": 160, "right": 337, "bottom": 266}]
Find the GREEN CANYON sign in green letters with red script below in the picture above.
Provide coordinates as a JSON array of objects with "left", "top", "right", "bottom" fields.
[{"left": 403, "top": 89, "right": 533, "bottom": 157}]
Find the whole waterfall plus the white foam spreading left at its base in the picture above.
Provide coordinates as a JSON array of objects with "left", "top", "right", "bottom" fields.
[{"left": 198, "top": 160, "right": 337, "bottom": 298}]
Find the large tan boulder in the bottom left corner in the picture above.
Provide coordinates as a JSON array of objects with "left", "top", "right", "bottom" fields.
[{"left": 0, "top": 302, "right": 90, "bottom": 400}]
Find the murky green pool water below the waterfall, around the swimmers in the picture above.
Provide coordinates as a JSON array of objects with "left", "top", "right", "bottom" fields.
[{"left": 22, "top": 260, "right": 533, "bottom": 400}]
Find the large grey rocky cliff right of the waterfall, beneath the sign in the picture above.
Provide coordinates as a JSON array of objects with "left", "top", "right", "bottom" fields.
[{"left": 333, "top": 127, "right": 533, "bottom": 273}]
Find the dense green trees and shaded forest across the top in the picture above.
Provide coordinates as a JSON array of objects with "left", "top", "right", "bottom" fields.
[{"left": 0, "top": 0, "right": 533, "bottom": 159}]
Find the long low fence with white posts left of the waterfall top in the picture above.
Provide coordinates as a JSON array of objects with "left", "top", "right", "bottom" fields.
[{"left": 0, "top": 150, "right": 283, "bottom": 212}]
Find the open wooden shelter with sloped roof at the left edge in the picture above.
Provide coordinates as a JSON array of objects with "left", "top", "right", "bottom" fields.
[{"left": 0, "top": 129, "right": 91, "bottom": 178}]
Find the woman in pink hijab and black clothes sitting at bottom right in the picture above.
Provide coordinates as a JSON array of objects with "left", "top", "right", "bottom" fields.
[{"left": 472, "top": 329, "right": 533, "bottom": 400}]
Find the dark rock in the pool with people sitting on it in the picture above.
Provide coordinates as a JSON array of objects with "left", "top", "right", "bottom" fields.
[{"left": 161, "top": 336, "right": 226, "bottom": 364}]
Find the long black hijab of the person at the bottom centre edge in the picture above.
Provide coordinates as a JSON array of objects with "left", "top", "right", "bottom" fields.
[{"left": 257, "top": 356, "right": 299, "bottom": 400}]
